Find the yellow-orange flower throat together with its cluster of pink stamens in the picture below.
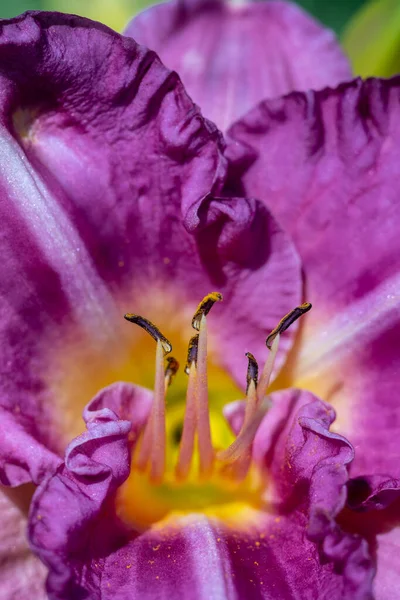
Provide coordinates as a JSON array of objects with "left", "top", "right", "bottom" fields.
[{"left": 117, "top": 292, "right": 311, "bottom": 527}]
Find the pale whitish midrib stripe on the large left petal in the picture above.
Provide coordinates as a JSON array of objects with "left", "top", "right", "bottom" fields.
[{"left": 0, "top": 127, "right": 116, "bottom": 340}]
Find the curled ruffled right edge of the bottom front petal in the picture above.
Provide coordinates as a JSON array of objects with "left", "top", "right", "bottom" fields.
[{"left": 224, "top": 390, "right": 374, "bottom": 599}]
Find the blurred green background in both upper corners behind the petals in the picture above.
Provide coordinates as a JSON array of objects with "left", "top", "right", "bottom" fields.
[{"left": 0, "top": 0, "right": 400, "bottom": 77}]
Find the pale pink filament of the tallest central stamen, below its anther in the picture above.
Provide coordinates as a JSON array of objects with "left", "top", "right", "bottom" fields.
[{"left": 196, "top": 314, "right": 214, "bottom": 476}]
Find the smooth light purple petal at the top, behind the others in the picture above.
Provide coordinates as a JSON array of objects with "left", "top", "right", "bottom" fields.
[{"left": 125, "top": 0, "right": 351, "bottom": 130}]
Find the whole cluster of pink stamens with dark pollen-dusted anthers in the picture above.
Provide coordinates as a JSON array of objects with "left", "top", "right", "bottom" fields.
[{"left": 124, "top": 292, "right": 311, "bottom": 484}]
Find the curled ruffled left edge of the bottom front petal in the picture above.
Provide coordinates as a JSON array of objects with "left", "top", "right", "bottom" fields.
[{"left": 29, "top": 398, "right": 131, "bottom": 599}]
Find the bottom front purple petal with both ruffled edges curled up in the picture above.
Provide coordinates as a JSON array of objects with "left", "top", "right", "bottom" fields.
[{"left": 30, "top": 391, "right": 373, "bottom": 600}]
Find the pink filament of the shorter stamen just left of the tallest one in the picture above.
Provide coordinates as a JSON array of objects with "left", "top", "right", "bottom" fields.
[{"left": 175, "top": 361, "right": 196, "bottom": 480}]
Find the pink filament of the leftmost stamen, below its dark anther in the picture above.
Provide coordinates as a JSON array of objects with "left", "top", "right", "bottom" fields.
[{"left": 150, "top": 340, "right": 166, "bottom": 483}]
